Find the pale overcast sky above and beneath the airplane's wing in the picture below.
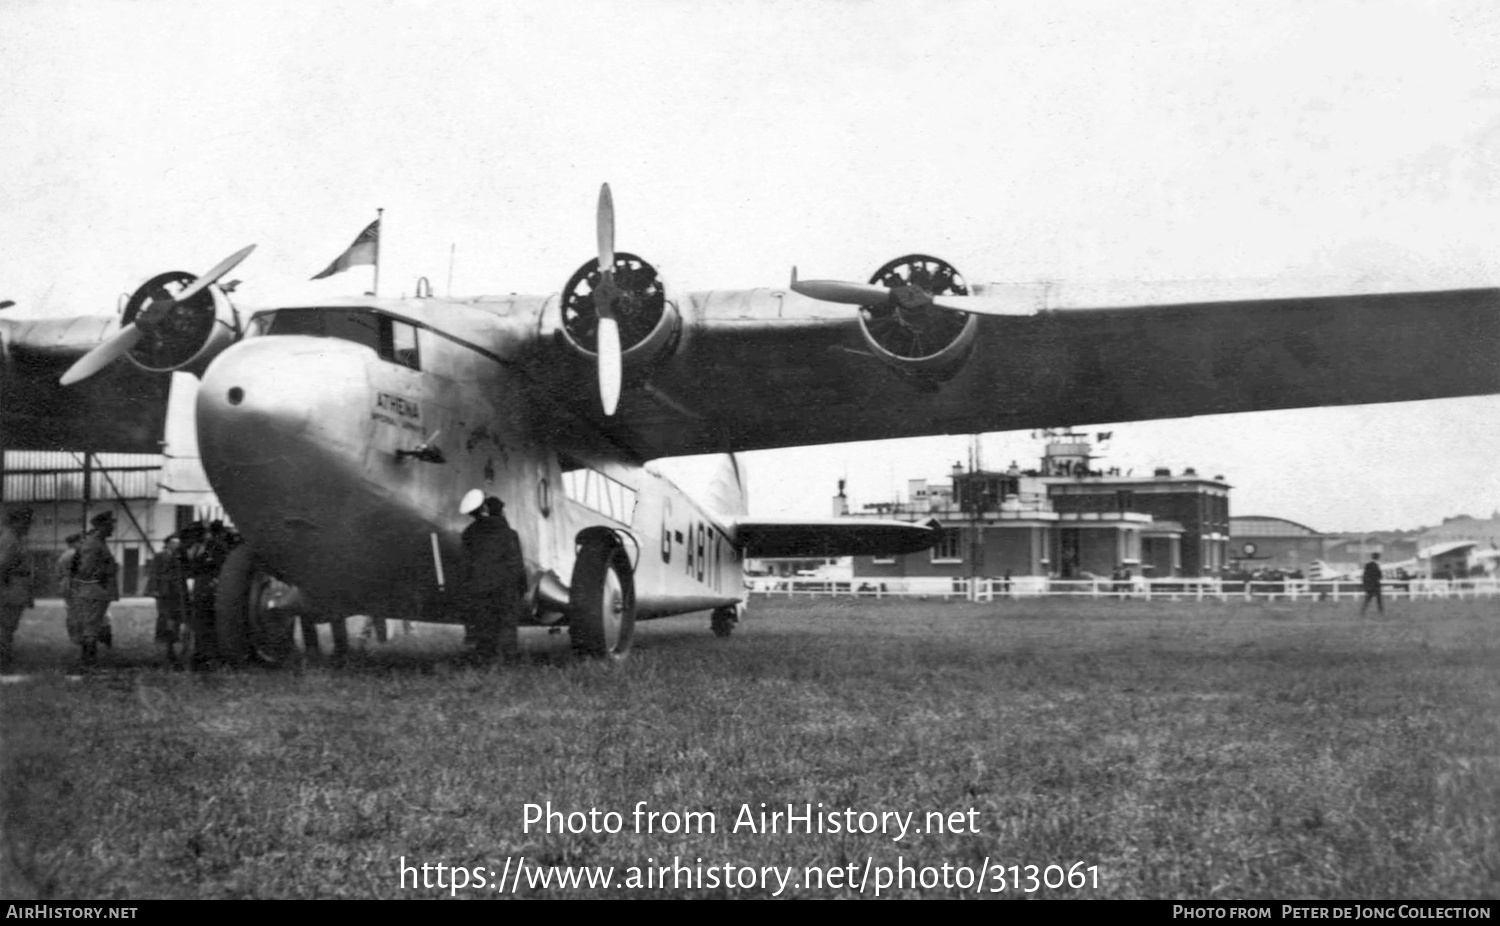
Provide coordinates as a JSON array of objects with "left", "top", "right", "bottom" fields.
[{"left": 0, "top": 0, "right": 1500, "bottom": 531}]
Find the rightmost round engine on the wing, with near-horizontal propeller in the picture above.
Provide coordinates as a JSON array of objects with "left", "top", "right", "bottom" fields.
[{"left": 860, "top": 254, "right": 980, "bottom": 387}]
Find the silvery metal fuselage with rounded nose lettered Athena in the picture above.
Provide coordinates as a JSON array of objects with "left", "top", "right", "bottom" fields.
[{"left": 198, "top": 300, "right": 744, "bottom": 621}]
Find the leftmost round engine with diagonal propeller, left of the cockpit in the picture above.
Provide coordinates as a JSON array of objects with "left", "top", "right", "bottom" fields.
[{"left": 120, "top": 270, "right": 240, "bottom": 375}]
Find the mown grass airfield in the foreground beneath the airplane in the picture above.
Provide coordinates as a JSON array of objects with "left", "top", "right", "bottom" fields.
[{"left": 0, "top": 591, "right": 1500, "bottom": 899}]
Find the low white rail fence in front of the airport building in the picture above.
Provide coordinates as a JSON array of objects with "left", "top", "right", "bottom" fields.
[{"left": 747, "top": 576, "right": 1500, "bottom": 602}]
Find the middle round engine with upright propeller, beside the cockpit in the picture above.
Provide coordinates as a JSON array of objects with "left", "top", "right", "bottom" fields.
[{"left": 560, "top": 251, "right": 683, "bottom": 381}]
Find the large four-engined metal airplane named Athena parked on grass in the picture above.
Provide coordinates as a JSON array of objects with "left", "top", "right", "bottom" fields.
[{"left": 0, "top": 185, "right": 1500, "bottom": 662}]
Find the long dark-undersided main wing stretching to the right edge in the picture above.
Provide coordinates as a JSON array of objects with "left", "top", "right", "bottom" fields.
[{"left": 542, "top": 282, "right": 1500, "bottom": 459}]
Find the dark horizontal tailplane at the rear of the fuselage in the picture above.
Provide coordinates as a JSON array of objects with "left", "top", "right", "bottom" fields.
[{"left": 731, "top": 518, "right": 939, "bottom": 557}]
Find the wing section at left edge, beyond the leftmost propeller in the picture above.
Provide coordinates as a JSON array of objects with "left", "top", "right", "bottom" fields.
[{"left": 0, "top": 317, "right": 171, "bottom": 453}]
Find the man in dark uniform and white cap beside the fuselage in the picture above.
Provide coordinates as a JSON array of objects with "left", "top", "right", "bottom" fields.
[{"left": 459, "top": 489, "right": 527, "bottom": 662}]
